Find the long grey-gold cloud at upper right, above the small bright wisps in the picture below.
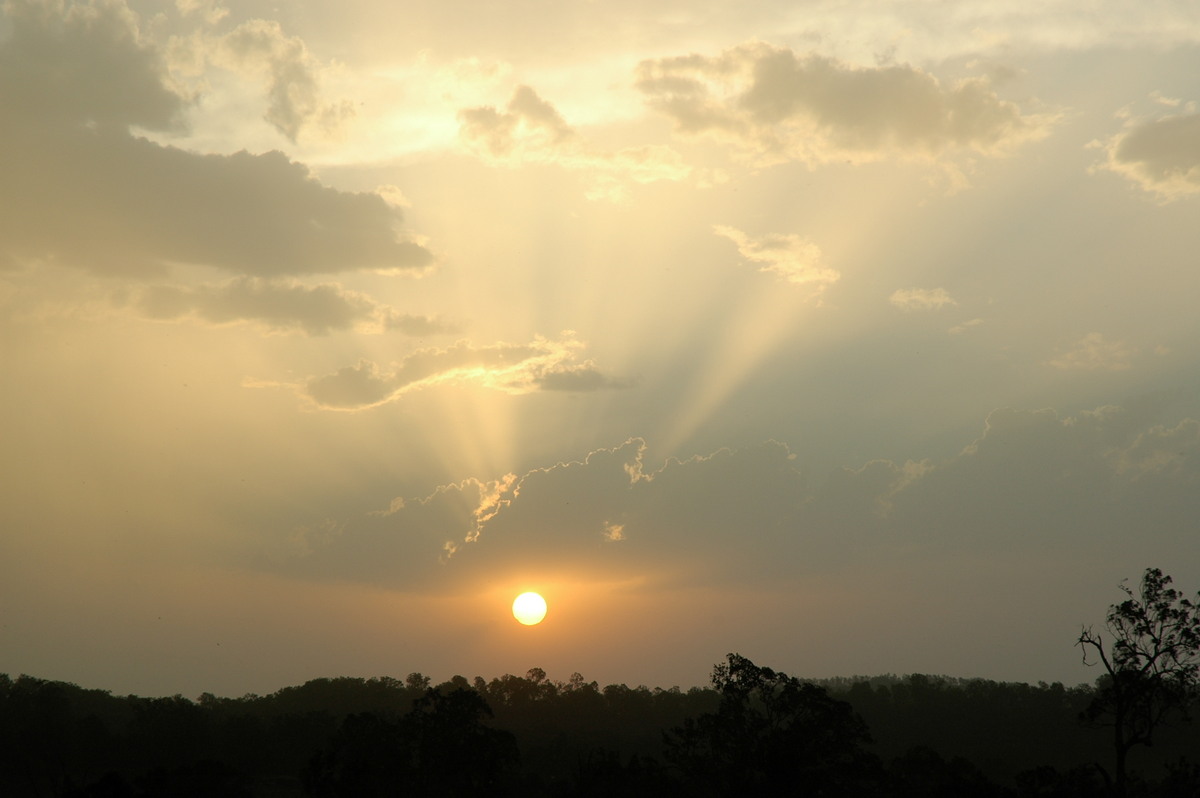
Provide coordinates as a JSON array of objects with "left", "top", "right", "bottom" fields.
[{"left": 637, "top": 42, "right": 1052, "bottom": 166}]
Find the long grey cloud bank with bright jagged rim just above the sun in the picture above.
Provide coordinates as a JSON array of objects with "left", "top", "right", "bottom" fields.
[{"left": 286, "top": 407, "right": 1200, "bottom": 586}]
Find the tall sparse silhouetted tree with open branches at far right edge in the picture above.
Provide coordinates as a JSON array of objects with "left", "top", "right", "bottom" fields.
[{"left": 1076, "top": 568, "right": 1200, "bottom": 798}]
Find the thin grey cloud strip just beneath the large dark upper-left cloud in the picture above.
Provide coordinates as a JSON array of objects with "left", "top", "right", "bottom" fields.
[{"left": 137, "top": 277, "right": 452, "bottom": 335}]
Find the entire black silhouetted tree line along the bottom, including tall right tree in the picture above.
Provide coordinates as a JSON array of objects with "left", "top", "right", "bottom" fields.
[{"left": 0, "top": 569, "right": 1200, "bottom": 798}]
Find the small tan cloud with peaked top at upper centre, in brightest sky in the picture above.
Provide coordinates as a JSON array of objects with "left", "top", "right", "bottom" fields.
[{"left": 458, "top": 85, "right": 696, "bottom": 200}]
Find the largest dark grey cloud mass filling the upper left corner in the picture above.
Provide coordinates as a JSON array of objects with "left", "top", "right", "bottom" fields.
[{"left": 0, "top": 2, "right": 432, "bottom": 276}]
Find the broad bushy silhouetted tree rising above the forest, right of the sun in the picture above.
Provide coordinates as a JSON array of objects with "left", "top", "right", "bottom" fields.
[{"left": 666, "top": 654, "right": 876, "bottom": 796}]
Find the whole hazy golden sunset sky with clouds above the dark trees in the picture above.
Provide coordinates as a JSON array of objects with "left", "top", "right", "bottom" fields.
[{"left": 0, "top": 0, "right": 1200, "bottom": 697}]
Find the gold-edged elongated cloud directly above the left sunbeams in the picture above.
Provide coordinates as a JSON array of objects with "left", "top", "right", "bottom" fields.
[{"left": 301, "top": 336, "right": 629, "bottom": 410}]
